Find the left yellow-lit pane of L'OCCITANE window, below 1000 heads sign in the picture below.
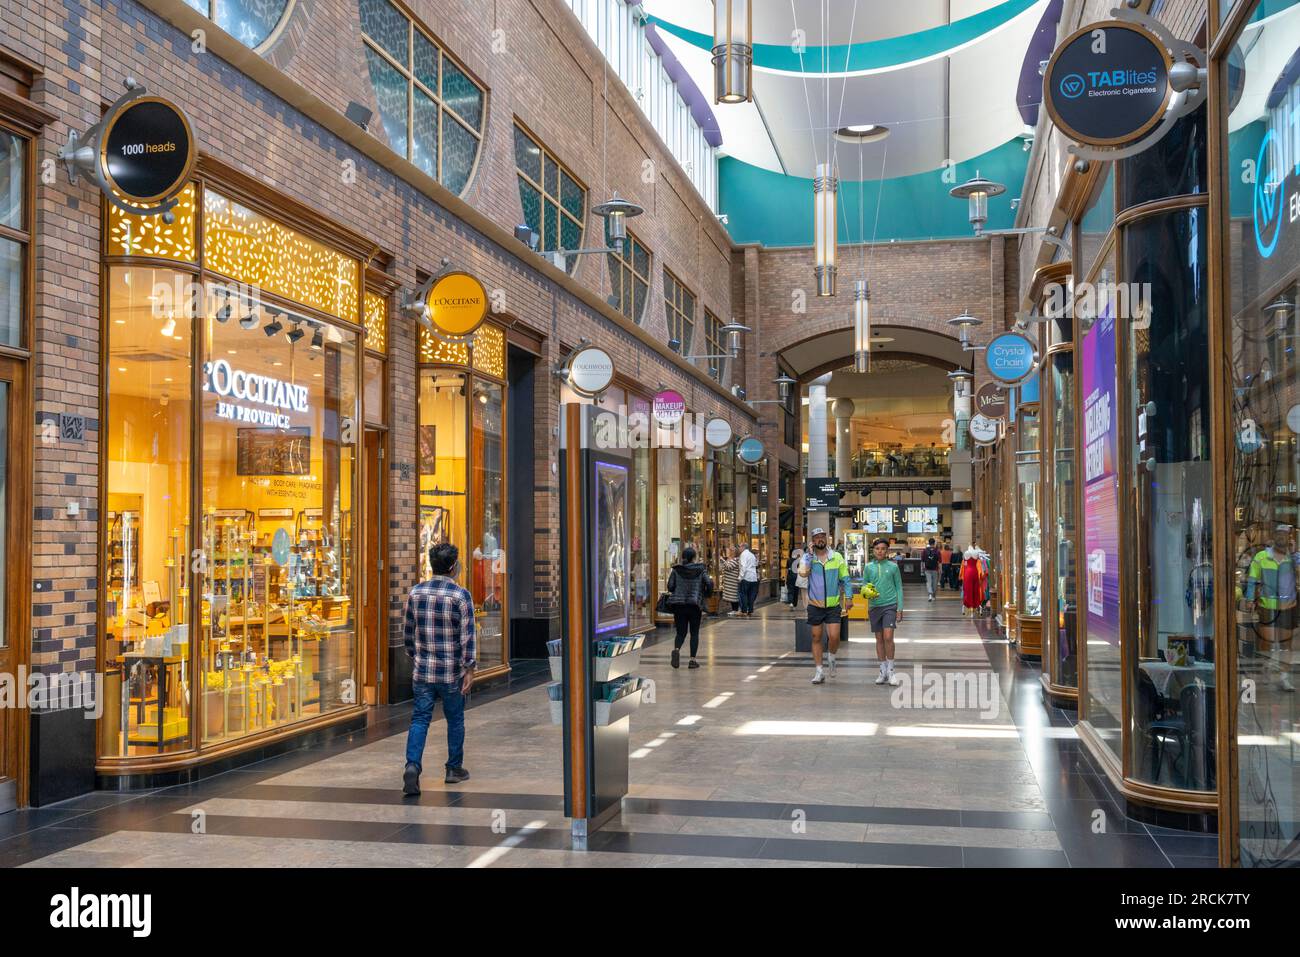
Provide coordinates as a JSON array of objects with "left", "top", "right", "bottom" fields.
[{"left": 100, "top": 267, "right": 198, "bottom": 757}]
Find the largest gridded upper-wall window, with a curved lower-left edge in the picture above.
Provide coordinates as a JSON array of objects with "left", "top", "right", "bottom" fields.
[{"left": 359, "top": 0, "right": 486, "bottom": 196}]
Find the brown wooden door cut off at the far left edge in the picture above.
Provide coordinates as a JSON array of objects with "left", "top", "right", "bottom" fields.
[{"left": 0, "top": 359, "right": 31, "bottom": 814}]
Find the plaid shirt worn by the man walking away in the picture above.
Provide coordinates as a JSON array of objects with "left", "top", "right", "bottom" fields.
[{"left": 402, "top": 575, "right": 476, "bottom": 684}]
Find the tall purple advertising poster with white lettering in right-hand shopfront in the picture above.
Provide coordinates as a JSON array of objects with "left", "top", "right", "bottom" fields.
[{"left": 1083, "top": 304, "right": 1119, "bottom": 646}]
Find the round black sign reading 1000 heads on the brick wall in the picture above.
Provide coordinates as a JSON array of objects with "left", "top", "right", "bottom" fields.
[{"left": 100, "top": 96, "right": 195, "bottom": 203}]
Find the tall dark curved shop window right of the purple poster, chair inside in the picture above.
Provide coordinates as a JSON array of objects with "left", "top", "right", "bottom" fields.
[{"left": 1114, "top": 207, "right": 1216, "bottom": 791}]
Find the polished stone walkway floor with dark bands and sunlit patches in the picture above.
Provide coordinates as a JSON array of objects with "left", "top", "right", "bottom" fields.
[{"left": 0, "top": 588, "right": 1217, "bottom": 867}]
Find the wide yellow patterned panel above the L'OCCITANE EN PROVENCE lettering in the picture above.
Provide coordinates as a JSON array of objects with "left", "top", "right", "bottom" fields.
[{"left": 203, "top": 190, "right": 360, "bottom": 322}]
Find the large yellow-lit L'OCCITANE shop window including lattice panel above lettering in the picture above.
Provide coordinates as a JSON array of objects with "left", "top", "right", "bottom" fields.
[{"left": 100, "top": 184, "right": 359, "bottom": 757}]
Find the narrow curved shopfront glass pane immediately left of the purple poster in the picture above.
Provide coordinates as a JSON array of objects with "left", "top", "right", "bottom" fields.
[{"left": 1044, "top": 352, "right": 1079, "bottom": 688}]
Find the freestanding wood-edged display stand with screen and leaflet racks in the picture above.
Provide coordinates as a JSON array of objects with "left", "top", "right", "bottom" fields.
[{"left": 555, "top": 404, "right": 641, "bottom": 850}]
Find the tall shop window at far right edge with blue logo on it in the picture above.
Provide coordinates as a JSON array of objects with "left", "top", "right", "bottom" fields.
[{"left": 1209, "top": 4, "right": 1300, "bottom": 867}]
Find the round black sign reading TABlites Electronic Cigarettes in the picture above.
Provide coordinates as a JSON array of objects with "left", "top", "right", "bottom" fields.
[{"left": 1043, "top": 20, "right": 1173, "bottom": 146}]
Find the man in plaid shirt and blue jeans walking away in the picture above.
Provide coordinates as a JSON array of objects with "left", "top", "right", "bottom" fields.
[{"left": 402, "top": 544, "right": 476, "bottom": 796}]
